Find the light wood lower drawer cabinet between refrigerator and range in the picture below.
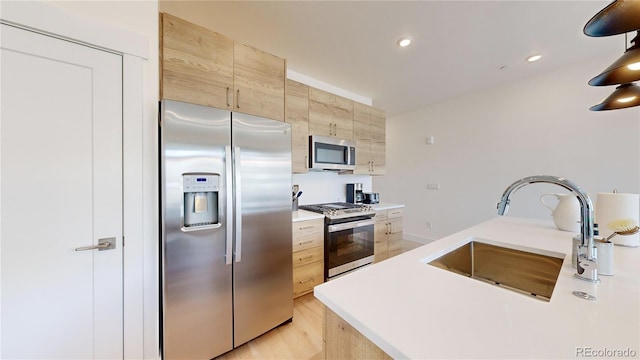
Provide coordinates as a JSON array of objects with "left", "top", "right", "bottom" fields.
[{"left": 293, "top": 219, "right": 324, "bottom": 298}]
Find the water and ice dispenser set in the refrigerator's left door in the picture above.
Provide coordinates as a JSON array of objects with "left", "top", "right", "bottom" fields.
[{"left": 182, "top": 173, "right": 221, "bottom": 231}]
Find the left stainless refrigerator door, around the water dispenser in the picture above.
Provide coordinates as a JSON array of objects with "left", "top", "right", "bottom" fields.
[{"left": 160, "top": 100, "right": 233, "bottom": 359}]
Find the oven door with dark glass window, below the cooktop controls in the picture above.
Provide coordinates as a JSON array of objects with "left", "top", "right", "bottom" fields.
[{"left": 325, "top": 219, "right": 375, "bottom": 280}]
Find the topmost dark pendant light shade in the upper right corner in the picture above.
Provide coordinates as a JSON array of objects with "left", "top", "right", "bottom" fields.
[{"left": 583, "top": 0, "right": 640, "bottom": 37}]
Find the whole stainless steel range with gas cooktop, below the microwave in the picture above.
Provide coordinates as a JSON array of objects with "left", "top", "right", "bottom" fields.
[{"left": 299, "top": 202, "right": 376, "bottom": 280}]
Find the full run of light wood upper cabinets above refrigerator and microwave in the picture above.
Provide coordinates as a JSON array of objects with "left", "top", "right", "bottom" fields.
[{"left": 160, "top": 13, "right": 386, "bottom": 175}]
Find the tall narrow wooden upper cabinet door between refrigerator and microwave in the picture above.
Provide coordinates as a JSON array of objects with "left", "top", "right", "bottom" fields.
[{"left": 285, "top": 80, "right": 309, "bottom": 173}]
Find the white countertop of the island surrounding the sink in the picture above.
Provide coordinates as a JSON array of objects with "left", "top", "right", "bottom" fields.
[{"left": 314, "top": 216, "right": 640, "bottom": 359}]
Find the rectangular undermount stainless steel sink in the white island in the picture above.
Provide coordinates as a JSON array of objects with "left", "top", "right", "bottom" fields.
[{"left": 423, "top": 238, "right": 565, "bottom": 301}]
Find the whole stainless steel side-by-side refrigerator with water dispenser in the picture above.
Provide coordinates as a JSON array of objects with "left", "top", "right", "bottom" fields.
[{"left": 160, "top": 100, "right": 293, "bottom": 359}]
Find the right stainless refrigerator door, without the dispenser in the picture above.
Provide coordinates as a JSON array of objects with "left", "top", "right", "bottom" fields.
[{"left": 232, "top": 113, "right": 293, "bottom": 347}]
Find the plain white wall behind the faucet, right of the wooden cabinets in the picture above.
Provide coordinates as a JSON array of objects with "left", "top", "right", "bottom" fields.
[{"left": 373, "top": 54, "right": 640, "bottom": 242}]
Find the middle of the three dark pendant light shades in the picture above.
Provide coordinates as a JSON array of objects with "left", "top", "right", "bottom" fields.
[{"left": 589, "top": 31, "right": 640, "bottom": 86}]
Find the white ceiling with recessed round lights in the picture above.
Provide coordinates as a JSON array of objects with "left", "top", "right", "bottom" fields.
[{"left": 159, "top": 0, "right": 625, "bottom": 116}]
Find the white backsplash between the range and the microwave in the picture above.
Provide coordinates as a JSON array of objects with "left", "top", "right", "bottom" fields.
[{"left": 291, "top": 171, "right": 372, "bottom": 205}]
